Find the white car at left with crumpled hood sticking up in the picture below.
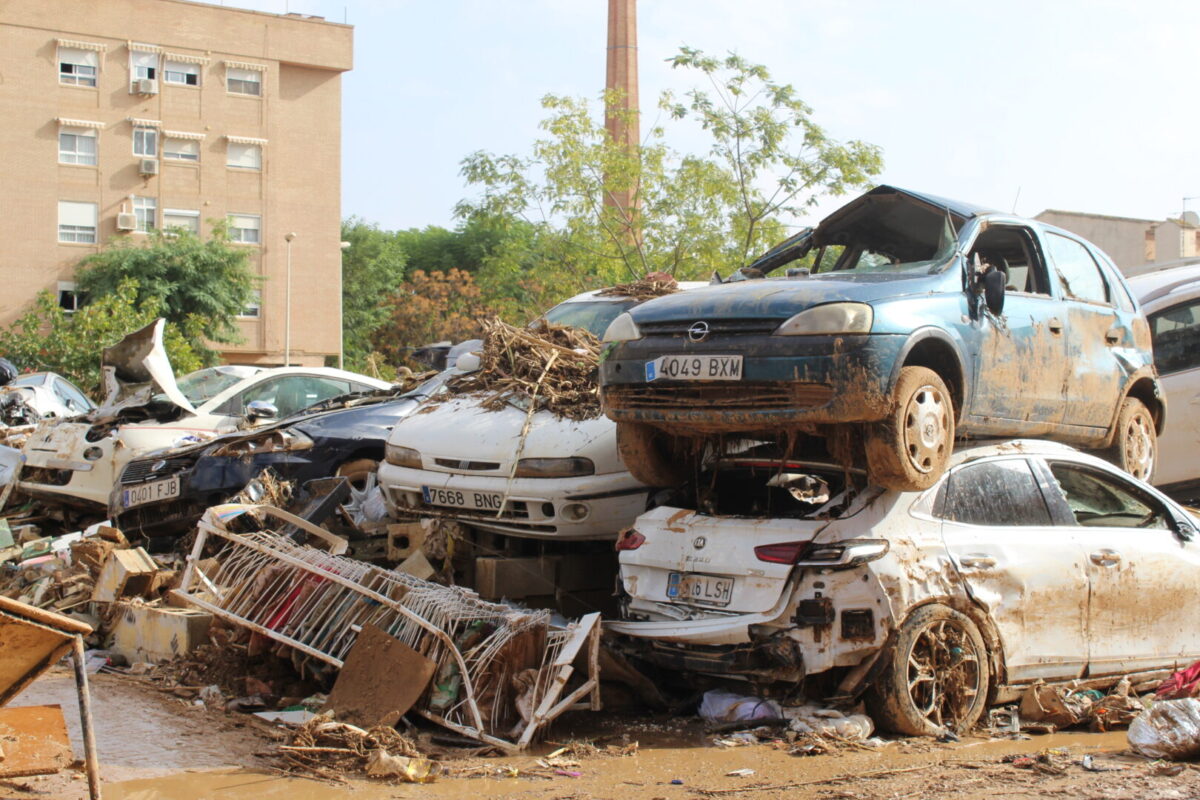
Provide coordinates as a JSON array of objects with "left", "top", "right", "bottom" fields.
[{"left": 18, "top": 320, "right": 390, "bottom": 511}]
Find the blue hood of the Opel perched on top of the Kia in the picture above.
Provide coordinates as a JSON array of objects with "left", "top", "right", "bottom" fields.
[{"left": 629, "top": 272, "right": 944, "bottom": 325}]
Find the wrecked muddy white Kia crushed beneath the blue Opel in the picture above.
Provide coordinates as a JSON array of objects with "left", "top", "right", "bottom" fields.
[{"left": 607, "top": 441, "right": 1200, "bottom": 735}]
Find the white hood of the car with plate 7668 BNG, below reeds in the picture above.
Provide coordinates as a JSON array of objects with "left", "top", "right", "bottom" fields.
[{"left": 388, "top": 395, "right": 625, "bottom": 474}]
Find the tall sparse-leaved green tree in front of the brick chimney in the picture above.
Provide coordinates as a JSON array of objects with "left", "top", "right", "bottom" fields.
[{"left": 456, "top": 48, "right": 882, "bottom": 292}]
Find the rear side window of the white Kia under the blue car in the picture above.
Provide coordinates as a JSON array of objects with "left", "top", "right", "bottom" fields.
[{"left": 942, "top": 458, "right": 1051, "bottom": 528}]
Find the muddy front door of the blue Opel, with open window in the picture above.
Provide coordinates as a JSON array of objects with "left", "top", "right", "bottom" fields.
[{"left": 967, "top": 223, "right": 1067, "bottom": 435}]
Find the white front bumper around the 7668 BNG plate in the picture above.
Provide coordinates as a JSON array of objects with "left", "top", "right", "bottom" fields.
[{"left": 379, "top": 463, "right": 650, "bottom": 540}]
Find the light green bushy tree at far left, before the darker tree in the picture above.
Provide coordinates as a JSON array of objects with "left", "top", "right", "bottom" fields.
[{"left": 0, "top": 278, "right": 203, "bottom": 401}]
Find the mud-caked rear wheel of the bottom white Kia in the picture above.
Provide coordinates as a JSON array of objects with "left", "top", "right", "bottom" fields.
[{"left": 866, "top": 603, "right": 989, "bottom": 736}]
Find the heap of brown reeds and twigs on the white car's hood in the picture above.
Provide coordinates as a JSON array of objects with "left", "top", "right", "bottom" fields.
[{"left": 446, "top": 318, "right": 600, "bottom": 420}]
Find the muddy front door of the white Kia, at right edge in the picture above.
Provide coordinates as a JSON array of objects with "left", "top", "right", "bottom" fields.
[{"left": 1048, "top": 459, "right": 1200, "bottom": 675}]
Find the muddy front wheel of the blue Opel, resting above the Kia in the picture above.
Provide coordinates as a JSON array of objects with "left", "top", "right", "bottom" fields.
[{"left": 866, "top": 367, "right": 954, "bottom": 492}]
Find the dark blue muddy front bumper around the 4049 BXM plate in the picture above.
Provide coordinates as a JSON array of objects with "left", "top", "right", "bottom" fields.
[{"left": 600, "top": 333, "right": 906, "bottom": 434}]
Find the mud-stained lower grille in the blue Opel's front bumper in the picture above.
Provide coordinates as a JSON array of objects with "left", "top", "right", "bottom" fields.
[{"left": 604, "top": 381, "right": 833, "bottom": 411}]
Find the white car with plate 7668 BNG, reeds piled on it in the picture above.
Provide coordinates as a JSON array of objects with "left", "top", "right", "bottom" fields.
[{"left": 379, "top": 283, "right": 703, "bottom": 540}]
